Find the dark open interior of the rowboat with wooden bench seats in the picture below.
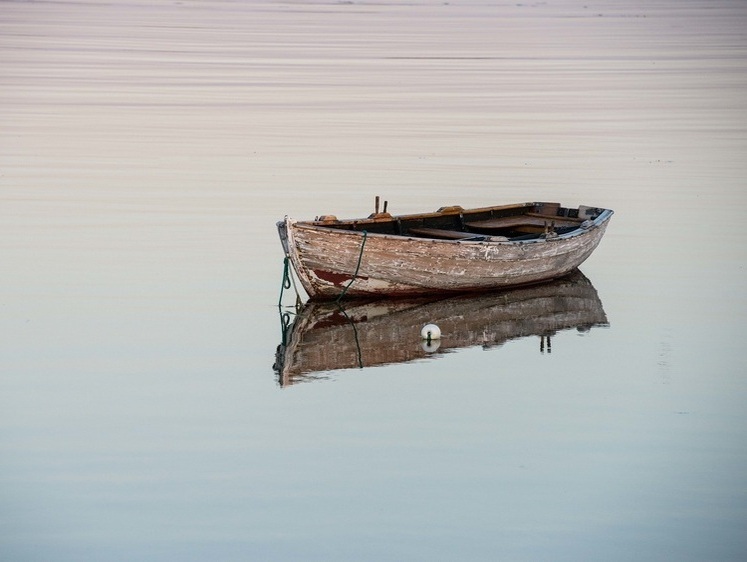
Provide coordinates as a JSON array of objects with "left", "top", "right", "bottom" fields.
[{"left": 312, "top": 203, "right": 602, "bottom": 241}]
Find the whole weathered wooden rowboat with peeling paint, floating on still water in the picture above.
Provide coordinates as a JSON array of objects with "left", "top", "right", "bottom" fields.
[{"left": 277, "top": 198, "right": 612, "bottom": 299}]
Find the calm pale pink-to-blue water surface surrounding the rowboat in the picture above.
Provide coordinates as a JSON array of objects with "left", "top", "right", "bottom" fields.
[{"left": 0, "top": 0, "right": 747, "bottom": 561}]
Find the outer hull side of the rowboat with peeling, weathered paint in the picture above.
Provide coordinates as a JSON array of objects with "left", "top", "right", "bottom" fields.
[{"left": 278, "top": 205, "right": 612, "bottom": 299}]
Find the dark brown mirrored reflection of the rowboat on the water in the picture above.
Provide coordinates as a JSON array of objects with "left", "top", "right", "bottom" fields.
[{"left": 273, "top": 270, "right": 608, "bottom": 386}]
